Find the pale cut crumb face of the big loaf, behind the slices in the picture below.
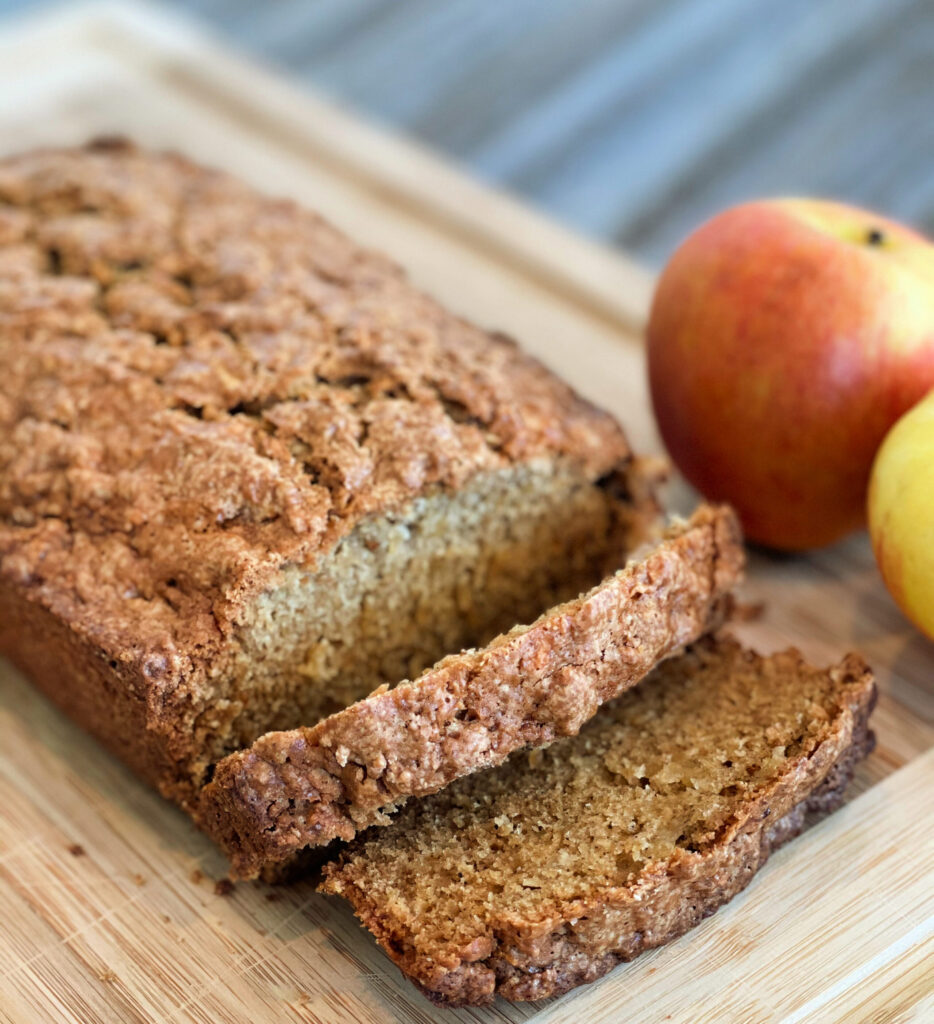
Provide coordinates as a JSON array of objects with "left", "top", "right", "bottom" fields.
[{"left": 206, "top": 463, "right": 633, "bottom": 759}]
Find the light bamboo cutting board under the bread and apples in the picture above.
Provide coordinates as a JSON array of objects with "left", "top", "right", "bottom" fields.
[{"left": 0, "top": 4, "right": 934, "bottom": 1024}]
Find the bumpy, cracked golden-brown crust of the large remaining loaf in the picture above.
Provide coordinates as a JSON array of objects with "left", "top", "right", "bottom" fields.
[{"left": 0, "top": 141, "right": 632, "bottom": 798}]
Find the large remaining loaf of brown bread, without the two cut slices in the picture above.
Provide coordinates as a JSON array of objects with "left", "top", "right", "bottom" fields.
[{"left": 0, "top": 140, "right": 657, "bottom": 808}]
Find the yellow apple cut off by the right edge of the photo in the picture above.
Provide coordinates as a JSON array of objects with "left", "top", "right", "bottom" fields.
[{"left": 867, "top": 395, "right": 934, "bottom": 639}]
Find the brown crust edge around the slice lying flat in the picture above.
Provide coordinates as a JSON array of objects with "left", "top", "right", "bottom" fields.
[{"left": 322, "top": 643, "right": 876, "bottom": 1006}]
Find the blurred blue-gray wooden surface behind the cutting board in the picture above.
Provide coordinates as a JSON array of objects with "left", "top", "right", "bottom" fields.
[{"left": 0, "top": 0, "right": 934, "bottom": 264}]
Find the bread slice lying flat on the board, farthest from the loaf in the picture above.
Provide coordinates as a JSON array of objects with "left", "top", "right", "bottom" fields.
[{"left": 322, "top": 639, "right": 875, "bottom": 1006}]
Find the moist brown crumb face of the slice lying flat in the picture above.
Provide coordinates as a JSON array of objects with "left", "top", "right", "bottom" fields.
[{"left": 332, "top": 648, "right": 837, "bottom": 951}]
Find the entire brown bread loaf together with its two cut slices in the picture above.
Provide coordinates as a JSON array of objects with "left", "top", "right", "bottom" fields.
[{"left": 0, "top": 140, "right": 874, "bottom": 1005}]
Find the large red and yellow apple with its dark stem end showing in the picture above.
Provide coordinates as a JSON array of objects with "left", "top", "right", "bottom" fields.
[{"left": 647, "top": 199, "right": 934, "bottom": 551}]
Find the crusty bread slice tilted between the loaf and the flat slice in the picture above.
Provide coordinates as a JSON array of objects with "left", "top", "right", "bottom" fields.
[{"left": 199, "top": 506, "right": 744, "bottom": 878}]
